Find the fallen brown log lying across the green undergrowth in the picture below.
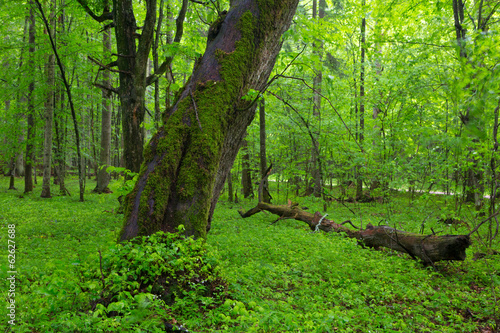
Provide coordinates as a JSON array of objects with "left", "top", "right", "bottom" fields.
[{"left": 239, "top": 202, "right": 471, "bottom": 264}]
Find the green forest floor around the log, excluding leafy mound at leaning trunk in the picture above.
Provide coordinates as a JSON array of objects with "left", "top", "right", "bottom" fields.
[{"left": 0, "top": 178, "right": 500, "bottom": 332}]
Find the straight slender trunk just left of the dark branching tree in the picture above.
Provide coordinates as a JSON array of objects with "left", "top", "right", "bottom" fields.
[{"left": 94, "top": 20, "right": 111, "bottom": 193}]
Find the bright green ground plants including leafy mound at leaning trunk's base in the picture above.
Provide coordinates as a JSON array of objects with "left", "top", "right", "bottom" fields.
[{"left": 0, "top": 179, "right": 500, "bottom": 333}]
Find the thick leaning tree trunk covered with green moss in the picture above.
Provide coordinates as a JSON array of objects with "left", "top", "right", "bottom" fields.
[{"left": 120, "top": 0, "right": 298, "bottom": 240}]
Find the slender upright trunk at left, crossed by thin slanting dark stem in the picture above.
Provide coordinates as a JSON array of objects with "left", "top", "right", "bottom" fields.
[{"left": 41, "top": 1, "right": 56, "bottom": 198}]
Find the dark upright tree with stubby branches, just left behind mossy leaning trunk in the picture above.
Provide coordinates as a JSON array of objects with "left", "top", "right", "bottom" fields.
[{"left": 78, "top": 0, "right": 188, "bottom": 172}]
